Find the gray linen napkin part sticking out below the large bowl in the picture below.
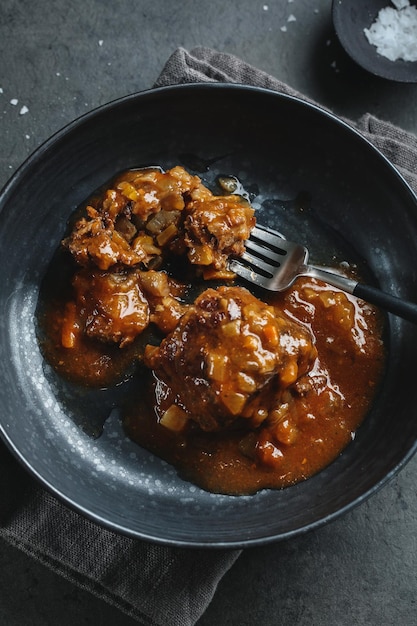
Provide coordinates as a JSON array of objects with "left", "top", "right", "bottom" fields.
[{"left": 0, "top": 444, "right": 240, "bottom": 626}]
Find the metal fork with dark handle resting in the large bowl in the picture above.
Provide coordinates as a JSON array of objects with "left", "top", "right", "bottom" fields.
[{"left": 229, "top": 224, "right": 417, "bottom": 323}]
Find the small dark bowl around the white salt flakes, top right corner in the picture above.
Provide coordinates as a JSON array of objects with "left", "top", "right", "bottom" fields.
[{"left": 332, "top": 0, "right": 417, "bottom": 83}]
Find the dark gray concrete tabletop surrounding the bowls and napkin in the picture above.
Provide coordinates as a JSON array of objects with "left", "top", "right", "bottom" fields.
[{"left": 0, "top": 0, "right": 417, "bottom": 626}]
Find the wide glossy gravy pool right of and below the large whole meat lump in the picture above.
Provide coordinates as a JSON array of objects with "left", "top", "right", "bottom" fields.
[{"left": 125, "top": 279, "right": 384, "bottom": 494}]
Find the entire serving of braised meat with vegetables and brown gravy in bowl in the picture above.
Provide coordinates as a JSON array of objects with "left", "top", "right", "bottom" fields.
[{"left": 36, "top": 166, "right": 384, "bottom": 494}]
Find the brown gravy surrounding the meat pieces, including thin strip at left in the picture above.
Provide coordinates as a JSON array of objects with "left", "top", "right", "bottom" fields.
[{"left": 38, "top": 270, "right": 384, "bottom": 494}]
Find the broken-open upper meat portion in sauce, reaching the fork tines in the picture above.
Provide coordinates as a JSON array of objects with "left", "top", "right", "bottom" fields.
[{"left": 63, "top": 166, "right": 255, "bottom": 278}]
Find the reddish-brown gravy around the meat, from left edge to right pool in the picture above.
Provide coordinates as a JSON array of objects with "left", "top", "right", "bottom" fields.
[{"left": 40, "top": 166, "right": 384, "bottom": 495}]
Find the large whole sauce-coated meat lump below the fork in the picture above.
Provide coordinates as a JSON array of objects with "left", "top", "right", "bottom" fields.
[{"left": 145, "top": 287, "right": 317, "bottom": 431}]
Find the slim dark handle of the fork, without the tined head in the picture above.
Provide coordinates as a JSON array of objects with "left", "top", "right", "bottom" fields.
[{"left": 307, "top": 265, "right": 417, "bottom": 324}]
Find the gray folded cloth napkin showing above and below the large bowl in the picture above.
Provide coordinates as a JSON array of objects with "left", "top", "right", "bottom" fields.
[{"left": 0, "top": 48, "right": 417, "bottom": 626}]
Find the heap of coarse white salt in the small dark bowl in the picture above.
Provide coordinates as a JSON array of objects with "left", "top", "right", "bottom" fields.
[{"left": 364, "top": 0, "right": 417, "bottom": 61}]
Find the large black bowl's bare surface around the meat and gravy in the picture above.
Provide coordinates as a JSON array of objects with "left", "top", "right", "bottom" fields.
[{"left": 0, "top": 84, "right": 417, "bottom": 547}]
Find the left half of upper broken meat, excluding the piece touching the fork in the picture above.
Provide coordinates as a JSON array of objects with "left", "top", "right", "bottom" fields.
[{"left": 63, "top": 167, "right": 201, "bottom": 270}]
